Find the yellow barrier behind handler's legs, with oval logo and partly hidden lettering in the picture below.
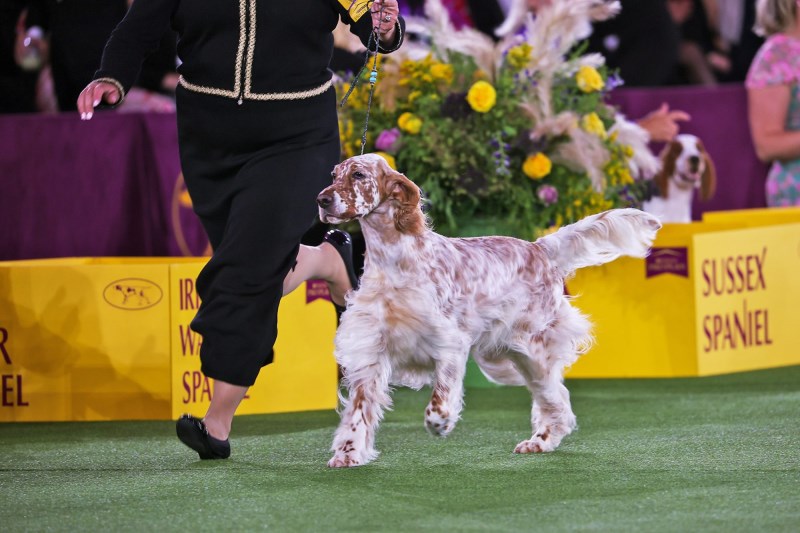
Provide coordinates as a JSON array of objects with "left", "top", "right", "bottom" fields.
[{"left": 0, "top": 258, "right": 337, "bottom": 422}]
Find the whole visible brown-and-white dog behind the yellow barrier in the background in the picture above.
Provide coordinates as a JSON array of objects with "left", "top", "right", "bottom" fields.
[{"left": 642, "top": 134, "right": 717, "bottom": 222}]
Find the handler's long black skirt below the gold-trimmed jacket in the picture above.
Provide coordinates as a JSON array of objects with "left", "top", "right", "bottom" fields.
[{"left": 177, "top": 86, "right": 340, "bottom": 386}]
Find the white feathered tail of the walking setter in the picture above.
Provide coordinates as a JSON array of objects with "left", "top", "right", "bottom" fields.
[{"left": 536, "top": 209, "right": 661, "bottom": 277}]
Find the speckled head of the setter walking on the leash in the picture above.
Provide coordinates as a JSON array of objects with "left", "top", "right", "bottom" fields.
[{"left": 317, "top": 154, "right": 426, "bottom": 234}]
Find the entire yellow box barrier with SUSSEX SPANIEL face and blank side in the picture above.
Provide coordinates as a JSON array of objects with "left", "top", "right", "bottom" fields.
[{"left": 567, "top": 209, "right": 800, "bottom": 378}]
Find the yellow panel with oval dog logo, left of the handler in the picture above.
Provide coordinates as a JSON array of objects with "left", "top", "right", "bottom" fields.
[{"left": 0, "top": 259, "right": 170, "bottom": 421}]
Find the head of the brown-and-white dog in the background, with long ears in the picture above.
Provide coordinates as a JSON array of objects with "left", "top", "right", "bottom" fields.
[{"left": 654, "top": 134, "right": 717, "bottom": 200}]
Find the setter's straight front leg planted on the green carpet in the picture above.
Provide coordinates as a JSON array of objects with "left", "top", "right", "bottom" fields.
[{"left": 328, "top": 362, "right": 392, "bottom": 468}]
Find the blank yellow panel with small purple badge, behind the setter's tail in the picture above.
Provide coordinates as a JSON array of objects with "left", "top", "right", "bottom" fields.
[{"left": 567, "top": 224, "right": 701, "bottom": 378}]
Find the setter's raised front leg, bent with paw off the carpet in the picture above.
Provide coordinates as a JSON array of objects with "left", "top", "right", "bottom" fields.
[{"left": 425, "top": 354, "right": 467, "bottom": 437}]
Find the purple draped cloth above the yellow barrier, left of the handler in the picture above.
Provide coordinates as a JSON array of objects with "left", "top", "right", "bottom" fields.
[{"left": 0, "top": 112, "right": 208, "bottom": 260}]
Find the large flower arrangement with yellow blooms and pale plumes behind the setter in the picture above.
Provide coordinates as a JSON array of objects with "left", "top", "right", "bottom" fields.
[{"left": 337, "top": 0, "right": 658, "bottom": 239}]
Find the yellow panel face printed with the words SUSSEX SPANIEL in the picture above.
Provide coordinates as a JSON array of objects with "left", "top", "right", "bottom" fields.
[{"left": 693, "top": 224, "right": 800, "bottom": 375}]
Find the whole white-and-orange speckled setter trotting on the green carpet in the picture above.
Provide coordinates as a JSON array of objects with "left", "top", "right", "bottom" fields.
[{"left": 317, "top": 154, "right": 661, "bottom": 467}]
